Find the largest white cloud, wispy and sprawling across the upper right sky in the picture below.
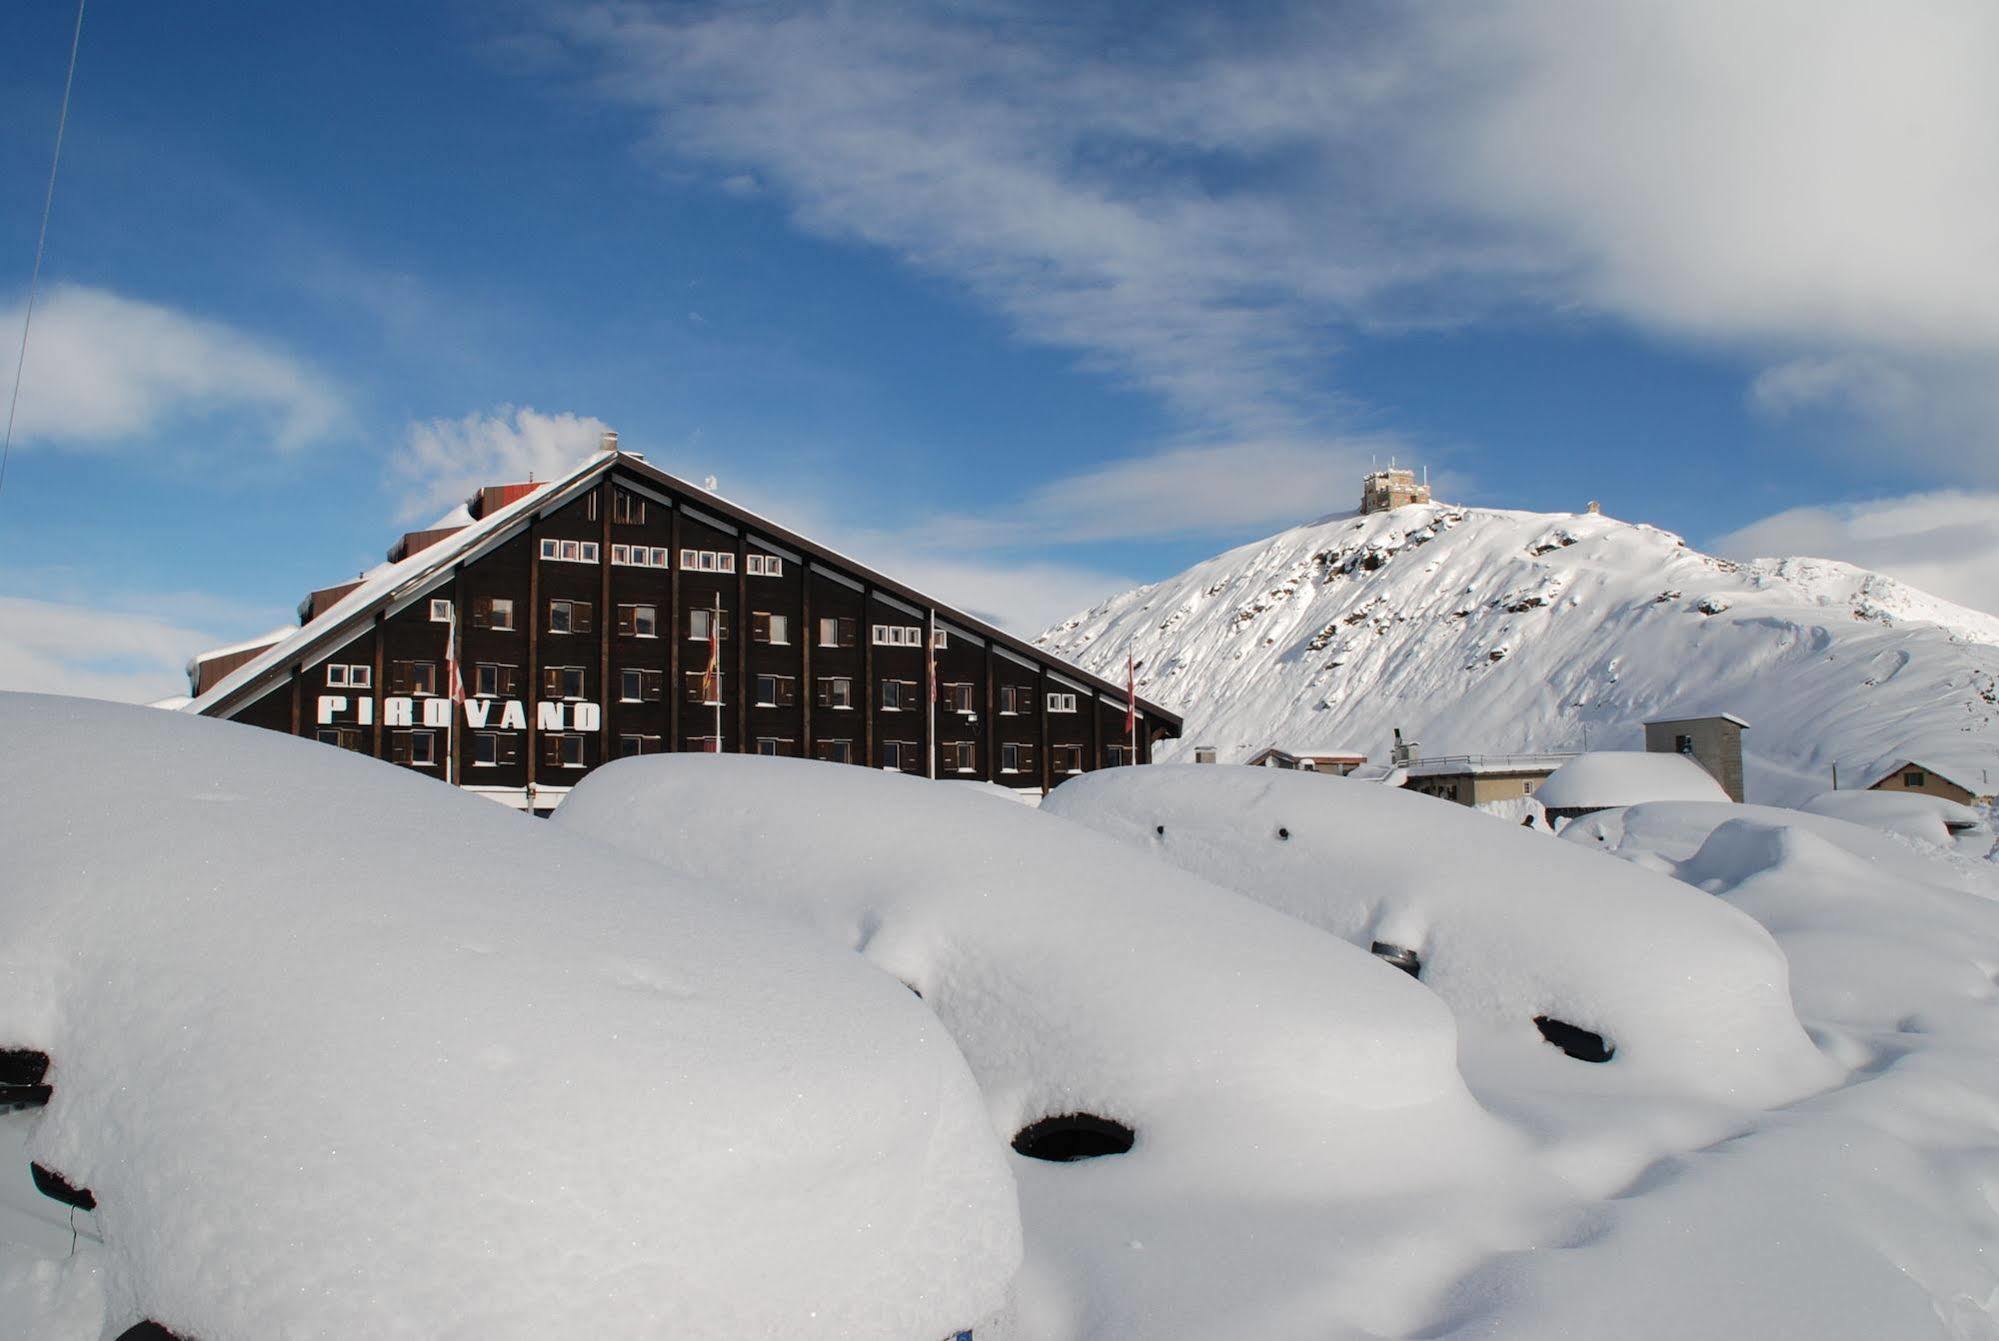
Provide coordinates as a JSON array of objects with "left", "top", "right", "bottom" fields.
[{"left": 554, "top": 0, "right": 1999, "bottom": 478}]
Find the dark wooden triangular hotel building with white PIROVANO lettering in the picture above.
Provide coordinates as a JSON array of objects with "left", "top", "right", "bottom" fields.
[{"left": 186, "top": 438, "right": 1181, "bottom": 809}]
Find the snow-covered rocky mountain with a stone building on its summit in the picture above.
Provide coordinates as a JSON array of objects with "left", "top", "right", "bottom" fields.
[{"left": 1039, "top": 504, "right": 1999, "bottom": 801}]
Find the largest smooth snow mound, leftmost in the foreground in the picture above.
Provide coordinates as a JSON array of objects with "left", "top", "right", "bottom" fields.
[{"left": 0, "top": 695, "right": 1019, "bottom": 1341}]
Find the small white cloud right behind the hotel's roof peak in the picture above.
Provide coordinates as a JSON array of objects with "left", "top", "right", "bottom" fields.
[{"left": 390, "top": 406, "right": 610, "bottom": 522}]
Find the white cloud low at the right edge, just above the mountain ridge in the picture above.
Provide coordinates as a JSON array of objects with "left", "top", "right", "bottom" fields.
[{"left": 1711, "top": 490, "right": 1999, "bottom": 616}]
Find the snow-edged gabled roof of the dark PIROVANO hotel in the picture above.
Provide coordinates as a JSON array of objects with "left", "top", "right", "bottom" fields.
[{"left": 182, "top": 452, "right": 1181, "bottom": 731}]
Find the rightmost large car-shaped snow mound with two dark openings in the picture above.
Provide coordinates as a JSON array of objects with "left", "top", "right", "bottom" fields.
[{"left": 1041, "top": 765, "right": 1833, "bottom": 1107}]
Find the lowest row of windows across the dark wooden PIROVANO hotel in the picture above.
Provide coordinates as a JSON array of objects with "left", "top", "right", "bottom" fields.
[{"left": 320, "top": 727, "right": 1129, "bottom": 773}]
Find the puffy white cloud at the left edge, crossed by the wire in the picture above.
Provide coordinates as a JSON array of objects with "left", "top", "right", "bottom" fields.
[{"left": 0, "top": 284, "right": 344, "bottom": 450}]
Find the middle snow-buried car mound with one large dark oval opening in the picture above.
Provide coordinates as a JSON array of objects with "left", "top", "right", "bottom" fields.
[{"left": 556, "top": 755, "right": 1519, "bottom": 1341}]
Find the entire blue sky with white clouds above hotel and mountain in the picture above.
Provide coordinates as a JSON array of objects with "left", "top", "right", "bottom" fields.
[{"left": 0, "top": 0, "right": 1999, "bottom": 697}]
